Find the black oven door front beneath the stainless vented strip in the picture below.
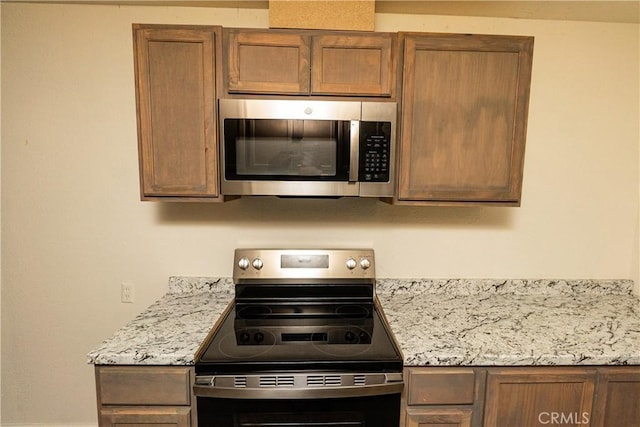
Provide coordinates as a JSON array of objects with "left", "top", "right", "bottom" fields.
[{"left": 197, "top": 393, "right": 400, "bottom": 427}]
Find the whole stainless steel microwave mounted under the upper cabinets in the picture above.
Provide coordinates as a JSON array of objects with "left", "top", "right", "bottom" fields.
[{"left": 219, "top": 99, "right": 396, "bottom": 197}]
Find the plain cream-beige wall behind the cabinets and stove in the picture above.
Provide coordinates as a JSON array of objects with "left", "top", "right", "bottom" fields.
[{"left": 1, "top": 3, "right": 640, "bottom": 425}]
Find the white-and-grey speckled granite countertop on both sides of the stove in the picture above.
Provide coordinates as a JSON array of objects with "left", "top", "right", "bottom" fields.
[{"left": 88, "top": 277, "right": 640, "bottom": 366}]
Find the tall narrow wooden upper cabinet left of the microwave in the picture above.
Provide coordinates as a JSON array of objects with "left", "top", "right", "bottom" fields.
[{"left": 133, "top": 24, "right": 222, "bottom": 201}]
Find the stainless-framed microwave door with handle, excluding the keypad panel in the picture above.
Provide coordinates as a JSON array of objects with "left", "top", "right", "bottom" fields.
[{"left": 220, "top": 99, "right": 361, "bottom": 196}]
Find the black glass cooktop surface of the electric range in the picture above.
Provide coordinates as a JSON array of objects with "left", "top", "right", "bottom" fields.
[{"left": 195, "top": 300, "right": 402, "bottom": 374}]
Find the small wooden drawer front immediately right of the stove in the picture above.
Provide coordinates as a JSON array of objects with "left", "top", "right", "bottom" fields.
[{"left": 407, "top": 368, "right": 476, "bottom": 405}]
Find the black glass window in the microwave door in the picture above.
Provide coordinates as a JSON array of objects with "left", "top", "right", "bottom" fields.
[{"left": 224, "top": 119, "right": 350, "bottom": 181}]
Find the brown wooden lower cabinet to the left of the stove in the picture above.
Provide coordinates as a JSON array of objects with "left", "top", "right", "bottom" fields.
[{"left": 95, "top": 365, "right": 196, "bottom": 427}]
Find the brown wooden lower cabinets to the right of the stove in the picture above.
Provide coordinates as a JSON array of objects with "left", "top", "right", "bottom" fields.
[{"left": 400, "top": 366, "right": 640, "bottom": 427}]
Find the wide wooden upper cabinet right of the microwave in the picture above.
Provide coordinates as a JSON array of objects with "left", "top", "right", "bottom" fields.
[{"left": 394, "top": 33, "right": 533, "bottom": 206}]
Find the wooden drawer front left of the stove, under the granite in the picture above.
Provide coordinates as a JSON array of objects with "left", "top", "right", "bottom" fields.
[{"left": 96, "top": 366, "right": 191, "bottom": 405}]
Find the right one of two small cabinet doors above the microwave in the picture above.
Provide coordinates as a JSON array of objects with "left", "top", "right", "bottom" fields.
[{"left": 311, "top": 33, "right": 396, "bottom": 97}]
